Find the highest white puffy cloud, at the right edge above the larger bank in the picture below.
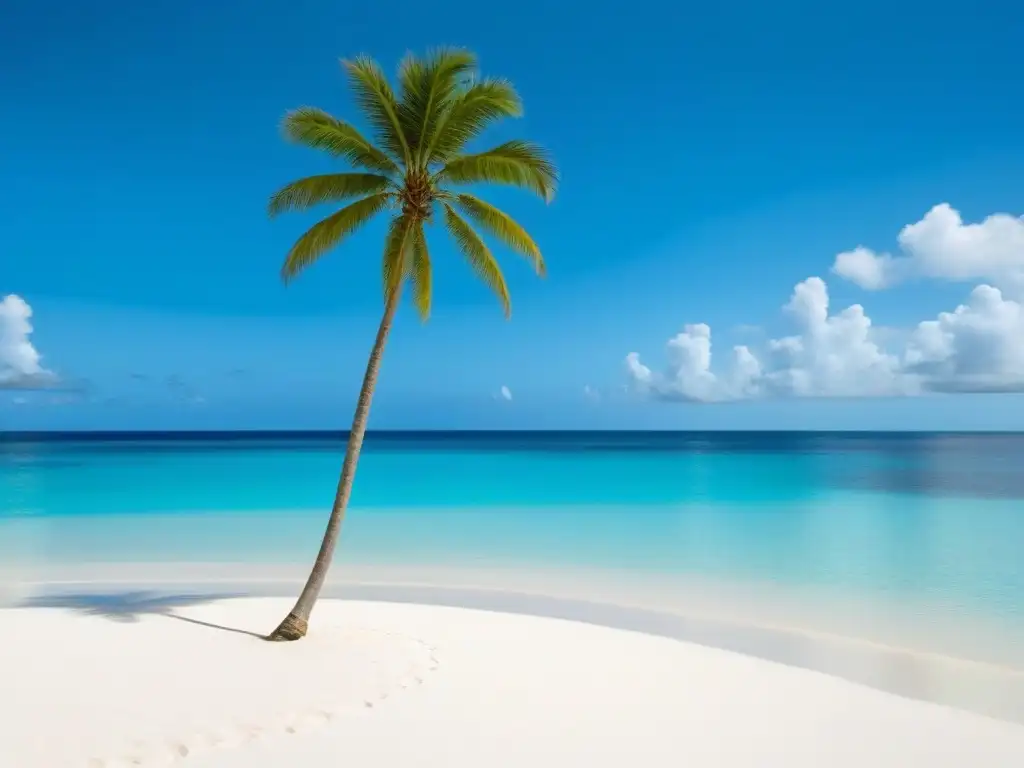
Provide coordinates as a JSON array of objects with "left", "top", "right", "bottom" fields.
[{"left": 833, "top": 203, "right": 1024, "bottom": 295}]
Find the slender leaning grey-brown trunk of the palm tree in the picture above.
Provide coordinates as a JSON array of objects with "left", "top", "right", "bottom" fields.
[{"left": 266, "top": 289, "right": 400, "bottom": 640}]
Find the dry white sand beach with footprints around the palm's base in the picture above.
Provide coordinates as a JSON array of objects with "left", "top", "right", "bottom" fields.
[{"left": 0, "top": 598, "right": 1024, "bottom": 768}]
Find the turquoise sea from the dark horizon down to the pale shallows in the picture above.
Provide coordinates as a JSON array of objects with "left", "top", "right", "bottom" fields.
[{"left": 0, "top": 433, "right": 1024, "bottom": 621}]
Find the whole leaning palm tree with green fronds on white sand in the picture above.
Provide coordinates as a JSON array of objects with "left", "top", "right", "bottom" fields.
[{"left": 260, "top": 49, "right": 558, "bottom": 640}]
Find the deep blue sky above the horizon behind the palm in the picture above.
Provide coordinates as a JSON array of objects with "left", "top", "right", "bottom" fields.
[{"left": 0, "top": 0, "right": 1024, "bottom": 429}]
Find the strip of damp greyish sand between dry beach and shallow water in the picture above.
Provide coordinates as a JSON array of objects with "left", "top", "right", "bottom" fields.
[{"left": 8, "top": 563, "right": 1024, "bottom": 723}]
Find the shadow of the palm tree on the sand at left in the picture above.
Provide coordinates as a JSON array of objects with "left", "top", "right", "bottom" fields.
[{"left": 19, "top": 591, "right": 265, "bottom": 640}]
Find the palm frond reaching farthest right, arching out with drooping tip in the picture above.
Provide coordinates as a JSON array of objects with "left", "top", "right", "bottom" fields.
[{"left": 436, "top": 140, "right": 558, "bottom": 203}]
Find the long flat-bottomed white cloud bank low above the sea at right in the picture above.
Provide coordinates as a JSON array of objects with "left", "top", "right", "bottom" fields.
[{"left": 626, "top": 278, "right": 1024, "bottom": 402}]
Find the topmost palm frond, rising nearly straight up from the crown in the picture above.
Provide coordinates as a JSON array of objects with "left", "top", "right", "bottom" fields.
[{"left": 398, "top": 48, "right": 476, "bottom": 168}]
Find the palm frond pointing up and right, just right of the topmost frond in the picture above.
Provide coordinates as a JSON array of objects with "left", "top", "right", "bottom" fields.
[{"left": 427, "top": 78, "right": 522, "bottom": 163}]
